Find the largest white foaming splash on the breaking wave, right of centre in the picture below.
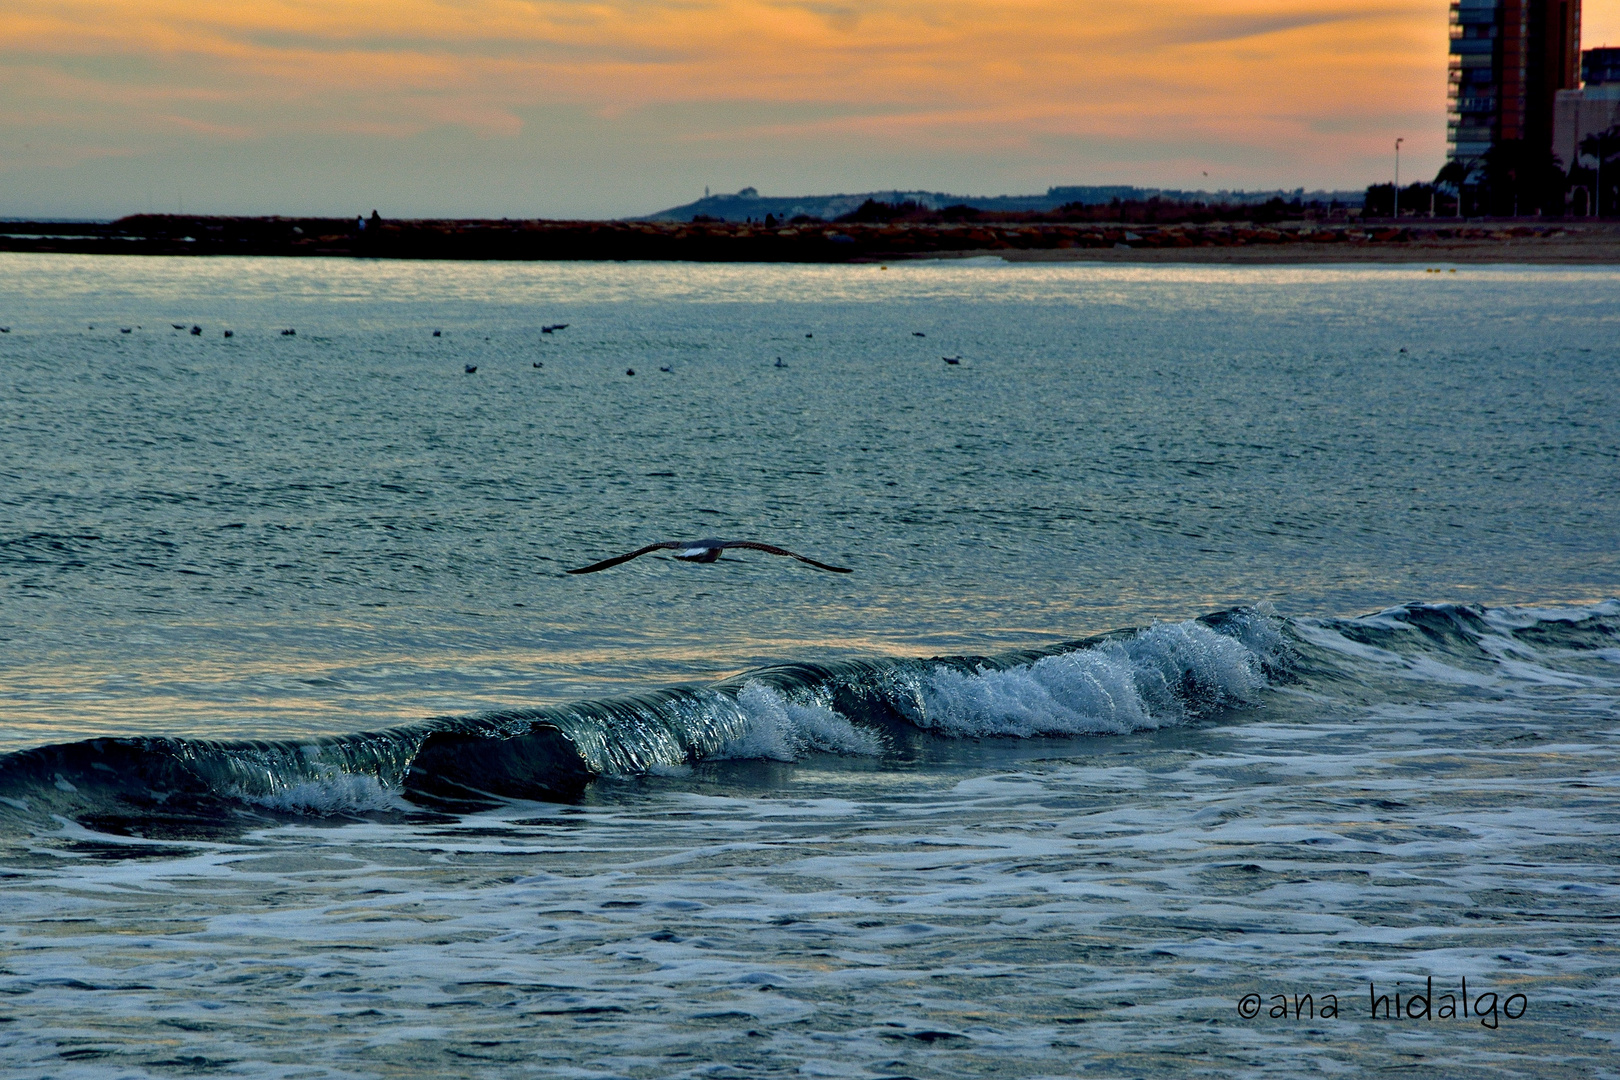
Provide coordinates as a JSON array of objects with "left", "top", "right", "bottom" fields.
[{"left": 919, "top": 620, "right": 1265, "bottom": 738}]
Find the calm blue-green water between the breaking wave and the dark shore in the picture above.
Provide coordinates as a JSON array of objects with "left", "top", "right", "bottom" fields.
[{"left": 0, "top": 256, "right": 1620, "bottom": 746}]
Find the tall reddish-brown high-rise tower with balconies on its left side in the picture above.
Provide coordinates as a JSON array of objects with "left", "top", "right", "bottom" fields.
[{"left": 1447, "top": 0, "right": 1581, "bottom": 164}]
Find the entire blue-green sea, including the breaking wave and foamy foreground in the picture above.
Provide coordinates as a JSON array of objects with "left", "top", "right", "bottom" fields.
[{"left": 0, "top": 254, "right": 1620, "bottom": 1078}]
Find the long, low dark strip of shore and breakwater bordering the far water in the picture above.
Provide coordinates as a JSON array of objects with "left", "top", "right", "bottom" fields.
[{"left": 0, "top": 215, "right": 1620, "bottom": 264}]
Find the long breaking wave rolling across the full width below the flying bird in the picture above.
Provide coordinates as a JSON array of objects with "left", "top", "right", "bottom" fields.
[{"left": 0, "top": 601, "right": 1620, "bottom": 836}]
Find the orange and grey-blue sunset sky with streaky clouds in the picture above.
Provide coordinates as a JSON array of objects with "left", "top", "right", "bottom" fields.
[{"left": 0, "top": 0, "right": 1620, "bottom": 217}]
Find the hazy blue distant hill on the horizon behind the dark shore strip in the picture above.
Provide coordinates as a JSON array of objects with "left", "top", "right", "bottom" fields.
[{"left": 633, "top": 185, "right": 1366, "bottom": 222}]
